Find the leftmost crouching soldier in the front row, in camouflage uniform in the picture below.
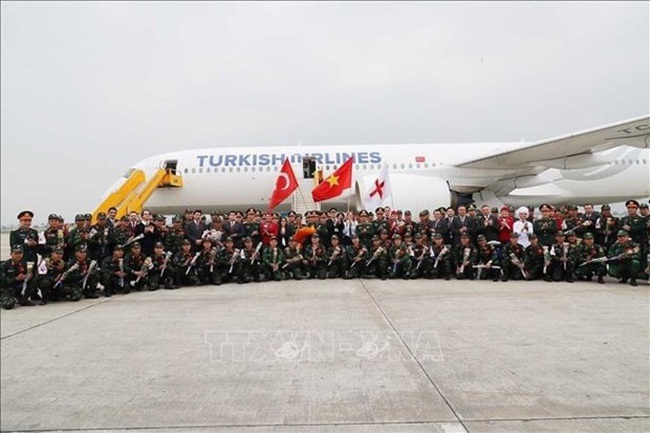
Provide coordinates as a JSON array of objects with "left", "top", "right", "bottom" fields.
[{"left": 0, "top": 245, "right": 36, "bottom": 310}]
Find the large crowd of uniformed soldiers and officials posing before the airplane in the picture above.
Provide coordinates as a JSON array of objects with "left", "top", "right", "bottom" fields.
[{"left": 0, "top": 200, "right": 650, "bottom": 309}]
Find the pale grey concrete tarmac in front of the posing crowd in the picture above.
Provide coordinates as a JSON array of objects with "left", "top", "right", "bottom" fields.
[{"left": 0, "top": 280, "right": 650, "bottom": 433}]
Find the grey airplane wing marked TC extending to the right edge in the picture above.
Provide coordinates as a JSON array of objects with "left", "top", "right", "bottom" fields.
[{"left": 458, "top": 115, "right": 650, "bottom": 169}]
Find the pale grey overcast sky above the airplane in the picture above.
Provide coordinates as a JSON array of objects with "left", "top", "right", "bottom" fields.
[{"left": 0, "top": 2, "right": 650, "bottom": 224}]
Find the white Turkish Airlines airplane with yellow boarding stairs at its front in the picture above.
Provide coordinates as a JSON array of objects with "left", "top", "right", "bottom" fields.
[{"left": 94, "top": 115, "right": 650, "bottom": 216}]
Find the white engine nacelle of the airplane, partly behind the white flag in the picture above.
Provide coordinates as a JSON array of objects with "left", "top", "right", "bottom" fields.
[{"left": 355, "top": 173, "right": 450, "bottom": 211}]
